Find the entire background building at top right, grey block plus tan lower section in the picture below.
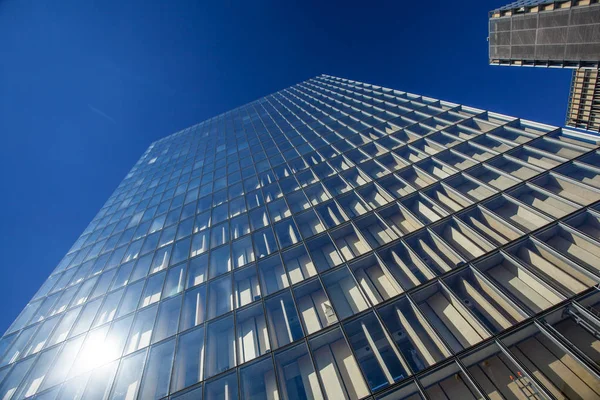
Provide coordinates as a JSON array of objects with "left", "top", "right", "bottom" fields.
[{"left": 488, "top": 0, "right": 600, "bottom": 132}]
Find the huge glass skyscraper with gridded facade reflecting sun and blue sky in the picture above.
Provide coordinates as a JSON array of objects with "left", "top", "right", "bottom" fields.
[{"left": 0, "top": 75, "right": 600, "bottom": 400}]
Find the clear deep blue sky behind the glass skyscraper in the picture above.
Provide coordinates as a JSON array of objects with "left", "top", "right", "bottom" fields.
[{"left": 0, "top": 0, "right": 570, "bottom": 332}]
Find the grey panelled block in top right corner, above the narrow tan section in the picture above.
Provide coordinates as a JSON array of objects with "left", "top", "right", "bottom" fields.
[{"left": 488, "top": 0, "right": 600, "bottom": 68}]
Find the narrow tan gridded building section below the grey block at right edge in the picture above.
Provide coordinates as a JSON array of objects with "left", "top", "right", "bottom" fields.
[{"left": 567, "top": 68, "right": 600, "bottom": 133}]
